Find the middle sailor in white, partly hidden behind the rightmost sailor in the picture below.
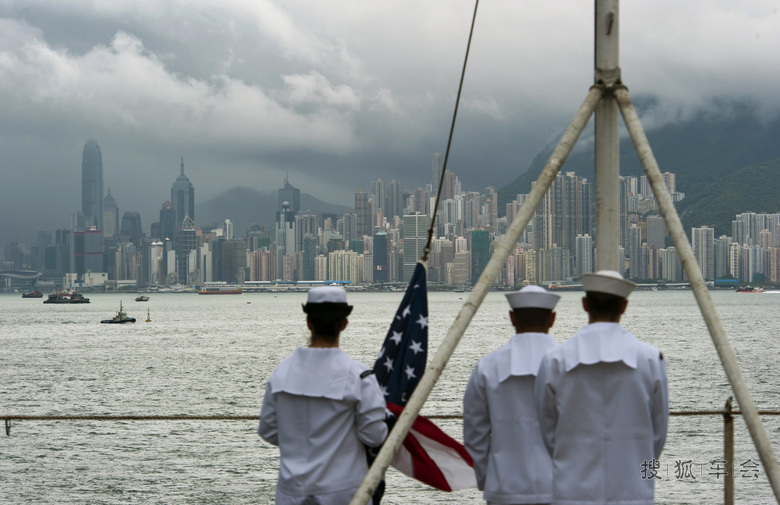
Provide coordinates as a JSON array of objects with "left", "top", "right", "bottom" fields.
[{"left": 463, "top": 286, "right": 560, "bottom": 504}]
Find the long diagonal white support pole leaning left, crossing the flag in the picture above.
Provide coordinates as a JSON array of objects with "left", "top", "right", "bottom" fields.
[{"left": 350, "top": 86, "right": 604, "bottom": 505}]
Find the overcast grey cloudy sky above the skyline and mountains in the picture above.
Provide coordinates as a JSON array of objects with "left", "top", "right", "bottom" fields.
[{"left": 0, "top": 0, "right": 780, "bottom": 245}]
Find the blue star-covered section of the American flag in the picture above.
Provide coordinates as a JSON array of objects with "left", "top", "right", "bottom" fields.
[{"left": 374, "top": 263, "right": 428, "bottom": 406}]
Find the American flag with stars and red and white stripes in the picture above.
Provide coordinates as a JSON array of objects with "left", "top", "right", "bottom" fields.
[{"left": 374, "top": 263, "right": 476, "bottom": 491}]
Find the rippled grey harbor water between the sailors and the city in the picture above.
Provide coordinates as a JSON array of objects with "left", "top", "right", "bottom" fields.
[{"left": 0, "top": 290, "right": 780, "bottom": 505}]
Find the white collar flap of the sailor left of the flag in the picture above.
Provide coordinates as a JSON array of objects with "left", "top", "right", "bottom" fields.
[{"left": 271, "top": 347, "right": 350, "bottom": 400}]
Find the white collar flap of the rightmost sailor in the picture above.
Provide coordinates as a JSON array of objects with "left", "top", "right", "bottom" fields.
[{"left": 563, "top": 323, "right": 639, "bottom": 372}]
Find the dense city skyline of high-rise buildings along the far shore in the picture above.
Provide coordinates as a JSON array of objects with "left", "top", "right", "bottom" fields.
[{"left": 1, "top": 148, "right": 780, "bottom": 289}]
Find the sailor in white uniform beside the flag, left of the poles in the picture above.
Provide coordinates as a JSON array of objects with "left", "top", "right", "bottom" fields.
[{"left": 258, "top": 287, "right": 387, "bottom": 505}]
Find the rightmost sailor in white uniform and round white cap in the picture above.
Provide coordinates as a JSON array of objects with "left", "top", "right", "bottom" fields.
[{"left": 535, "top": 270, "right": 669, "bottom": 505}]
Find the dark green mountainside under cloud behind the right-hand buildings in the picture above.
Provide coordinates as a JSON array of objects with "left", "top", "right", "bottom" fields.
[{"left": 498, "top": 99, "right": 780, "bottom": 225}]
